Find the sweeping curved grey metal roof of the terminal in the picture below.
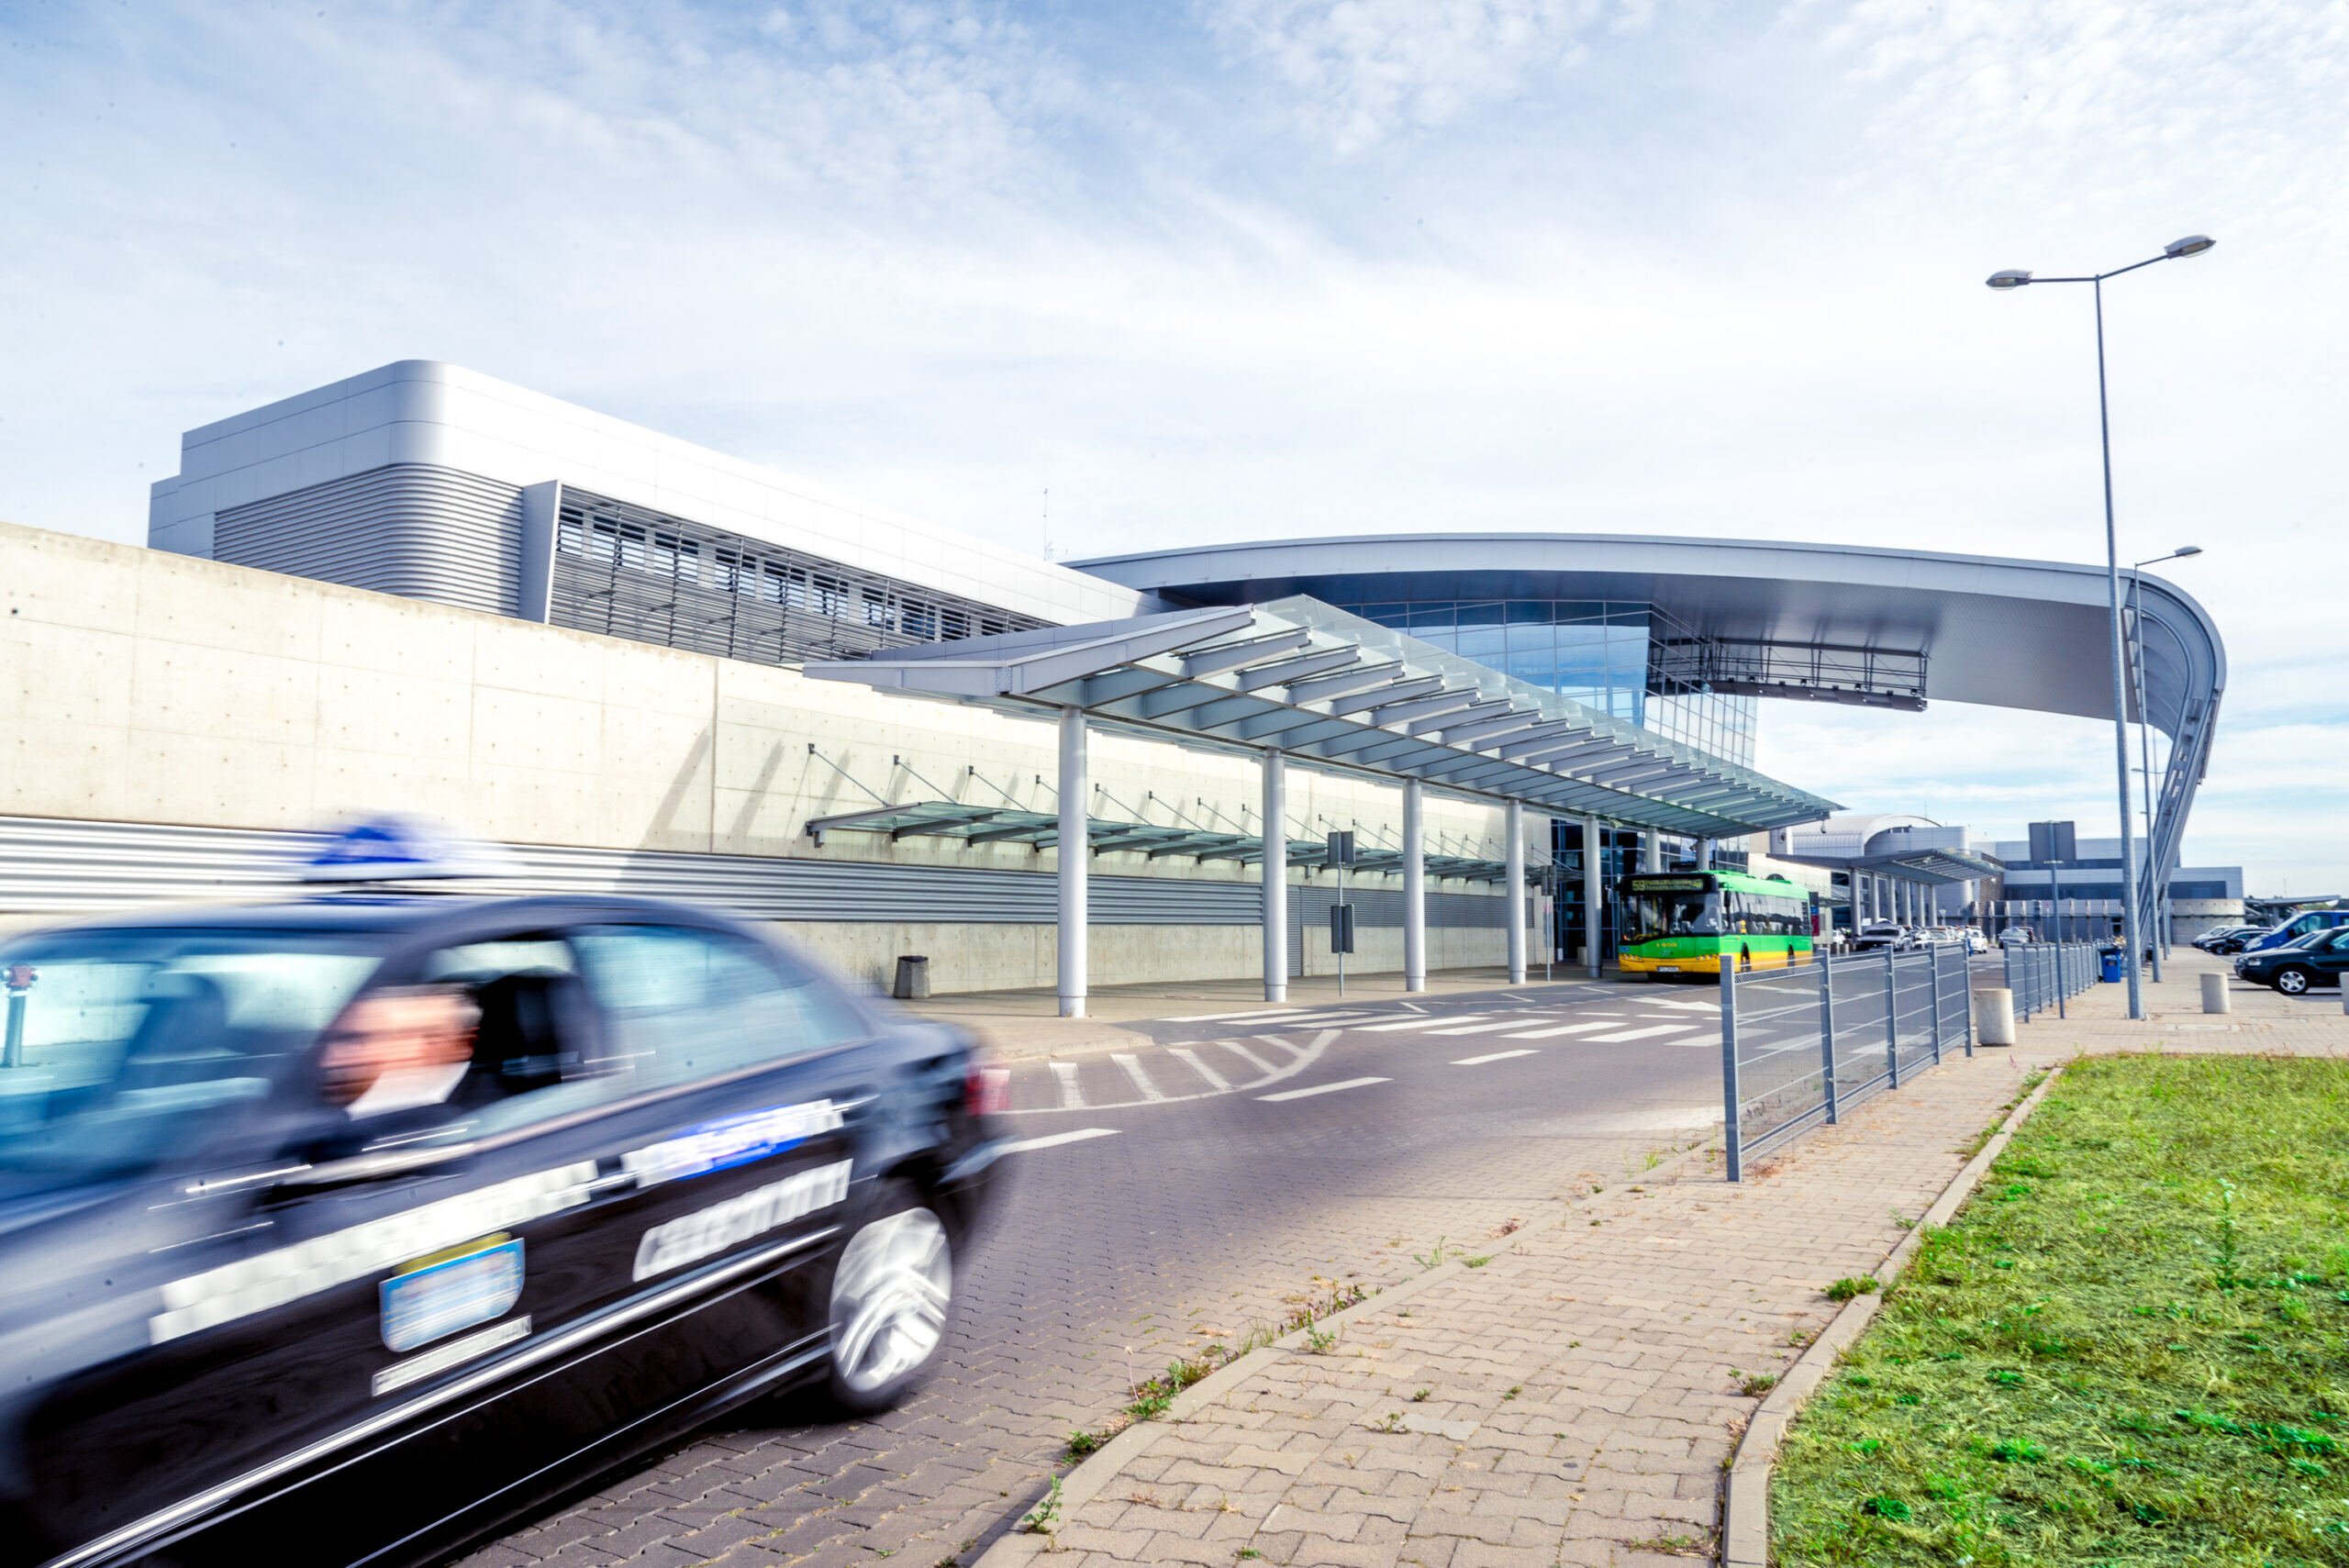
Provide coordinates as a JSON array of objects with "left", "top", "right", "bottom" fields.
[{"left": 1071, "top": 533, "right": 2227, "bottom": 910}]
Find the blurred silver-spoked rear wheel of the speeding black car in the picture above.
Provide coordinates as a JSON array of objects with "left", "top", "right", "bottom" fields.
[{"left": 829, "top": 1181, "right": 953, "bottom": 1416}]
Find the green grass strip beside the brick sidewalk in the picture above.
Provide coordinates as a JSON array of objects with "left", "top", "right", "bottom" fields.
[{"left": 1771, "top": 1056, "right": 2349, "bottom": 1568}]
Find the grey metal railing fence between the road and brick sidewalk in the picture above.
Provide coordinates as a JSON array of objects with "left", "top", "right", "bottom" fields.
[{"left": 1721, "top": 941, "right": 2098, "bottom": 1181}]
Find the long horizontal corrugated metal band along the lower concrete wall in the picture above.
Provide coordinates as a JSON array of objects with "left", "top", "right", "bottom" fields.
[{"left": 0, "top": 817, "right": 1501, "bottom": 929}]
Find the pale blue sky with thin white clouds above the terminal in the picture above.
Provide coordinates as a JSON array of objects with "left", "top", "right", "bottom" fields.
[{"left": 0, "top": 0, "right": 2349, "bottom": 892}]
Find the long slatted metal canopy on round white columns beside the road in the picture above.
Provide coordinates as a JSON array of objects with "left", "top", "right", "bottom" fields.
[{"left": 806, "top": 598, "right": 1834, "bottom": 1017}]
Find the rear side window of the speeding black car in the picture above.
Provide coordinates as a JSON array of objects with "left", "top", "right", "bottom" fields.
[{"left": 571, "top": 925, "right": 867, "bottom": 1087}]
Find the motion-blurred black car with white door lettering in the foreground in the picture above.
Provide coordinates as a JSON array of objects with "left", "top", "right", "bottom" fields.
[{"left": 0, "top": 895, "right": 1003, "bottom": 1565}]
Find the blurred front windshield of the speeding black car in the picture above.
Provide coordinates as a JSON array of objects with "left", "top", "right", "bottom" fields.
[{"left": 0, "top": 929, "right": 378, "bottom": 1190}]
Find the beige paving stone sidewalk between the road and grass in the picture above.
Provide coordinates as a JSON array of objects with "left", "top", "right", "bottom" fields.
[{"left": 1009, "top": 955, "right": 2349, "bottom": 1568}]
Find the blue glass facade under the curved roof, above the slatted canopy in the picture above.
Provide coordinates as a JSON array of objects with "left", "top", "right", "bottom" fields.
[{"left": 1330, "top": 598, "right": 1754, "bottom": 768}]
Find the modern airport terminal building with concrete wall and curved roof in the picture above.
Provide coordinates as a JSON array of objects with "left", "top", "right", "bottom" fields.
[{"left": 0, "top": 361, "right": 2224, "bottom": 1007}]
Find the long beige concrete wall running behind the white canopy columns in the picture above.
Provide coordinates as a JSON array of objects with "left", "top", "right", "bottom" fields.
[{"left": 0, "top": 524, "right": 1545, "bottom": 991}]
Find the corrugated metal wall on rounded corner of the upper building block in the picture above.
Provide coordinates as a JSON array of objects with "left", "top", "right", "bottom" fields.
[{"left": 211, "top": 462, "right": 521, "bottom": 615}]
